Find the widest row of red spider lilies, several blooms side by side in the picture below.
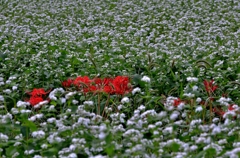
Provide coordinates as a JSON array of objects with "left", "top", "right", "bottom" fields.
[{"left": 62, "top": 76, "right": 132, "bottom": 95}]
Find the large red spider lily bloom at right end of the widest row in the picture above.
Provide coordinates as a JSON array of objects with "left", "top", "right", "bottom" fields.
[{"left": 112, "top": 76, "right": 132, "bottom": 95}]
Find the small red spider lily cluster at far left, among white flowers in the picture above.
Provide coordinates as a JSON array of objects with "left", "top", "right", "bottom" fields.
[{"left": 27, "top": 88, "right": 49, "bottom": 107}]
